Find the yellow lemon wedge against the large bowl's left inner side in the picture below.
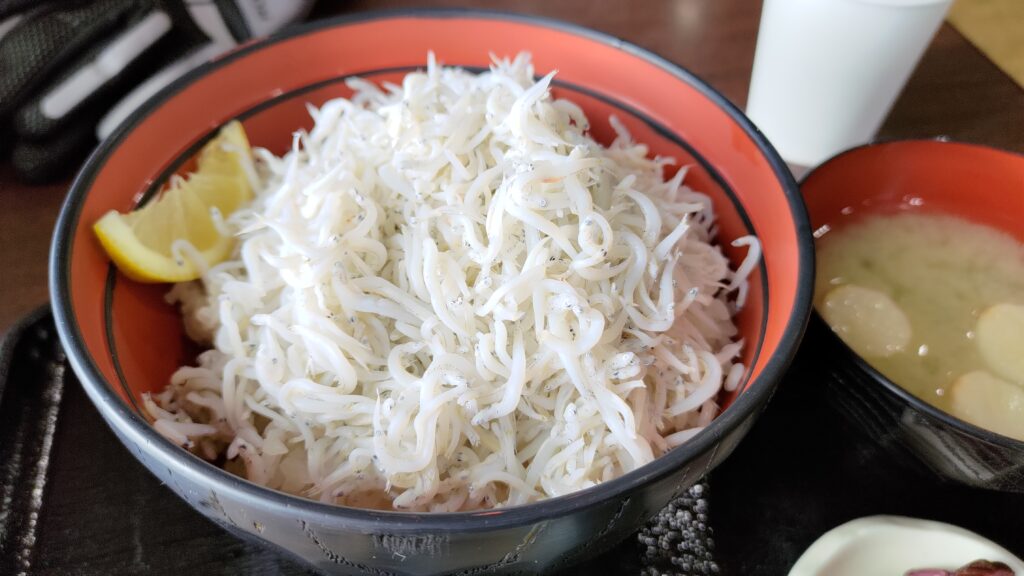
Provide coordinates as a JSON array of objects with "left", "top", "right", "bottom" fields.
[{"left": 92, "top": 122, "right": 253, "bottom": 283}]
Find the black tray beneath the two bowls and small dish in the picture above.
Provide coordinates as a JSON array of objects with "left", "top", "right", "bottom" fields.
[{"left": 0, "top": 310, "right": 1024, "bottom": 576}]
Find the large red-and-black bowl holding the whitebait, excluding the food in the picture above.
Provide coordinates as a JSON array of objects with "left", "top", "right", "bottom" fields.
[{"left": 51, "top": 10, "right": 813, "bottom": 575}]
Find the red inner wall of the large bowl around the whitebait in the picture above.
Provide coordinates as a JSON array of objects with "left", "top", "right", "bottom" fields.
[{"left": 53, "top": 12, "right": 812, "bottom": 455}]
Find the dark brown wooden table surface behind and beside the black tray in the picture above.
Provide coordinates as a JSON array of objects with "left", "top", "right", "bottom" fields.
[{"left": 0, "top": 0, "right": 1024, "bottom": 332}]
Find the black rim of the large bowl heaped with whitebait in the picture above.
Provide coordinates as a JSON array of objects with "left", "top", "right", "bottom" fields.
[{"left": 49, "top": 8, "right": 814, "bottom": 532}]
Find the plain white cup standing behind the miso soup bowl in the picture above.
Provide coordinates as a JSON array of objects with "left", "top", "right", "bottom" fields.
[{"left": 746, "top": 0, "right": 952, "bottom": 166}]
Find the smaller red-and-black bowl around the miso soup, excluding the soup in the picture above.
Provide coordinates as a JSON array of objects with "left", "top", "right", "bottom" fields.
[{"left": 801, "top": 140, "right": 1024, "bottom": 492}]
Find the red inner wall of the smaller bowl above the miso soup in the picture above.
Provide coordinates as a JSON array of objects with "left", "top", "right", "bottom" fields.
[{"left": 801, "top": 140, "right": 1024, "bottom": 430}]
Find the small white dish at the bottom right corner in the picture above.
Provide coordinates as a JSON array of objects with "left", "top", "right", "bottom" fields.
[{"left": 790, "top": 516, "right": 1024, "bottom": 576}]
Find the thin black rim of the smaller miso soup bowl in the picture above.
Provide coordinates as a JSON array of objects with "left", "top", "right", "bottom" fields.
[{"left": 800, "top": 136, "right": 1024, "bottom": 454}]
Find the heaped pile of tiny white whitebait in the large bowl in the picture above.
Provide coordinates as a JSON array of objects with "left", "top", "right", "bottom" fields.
[{"left": 145, "top": 54, "right": 760, "bottom": 511}]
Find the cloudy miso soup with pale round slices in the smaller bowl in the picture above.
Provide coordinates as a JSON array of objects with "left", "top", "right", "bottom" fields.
[{"left": 814, "top": 211, "right": 1024, "bottom": 440}]
